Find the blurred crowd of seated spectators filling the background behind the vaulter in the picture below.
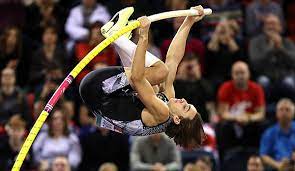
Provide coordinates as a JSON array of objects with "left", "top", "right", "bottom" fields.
[{"left": 0, "top": 0, "right": 295, "bottom": 171}]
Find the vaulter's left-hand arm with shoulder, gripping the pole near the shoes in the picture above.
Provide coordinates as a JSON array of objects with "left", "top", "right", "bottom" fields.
[{"left": 130, "top": 17, "right": 169, "bottom": 123}]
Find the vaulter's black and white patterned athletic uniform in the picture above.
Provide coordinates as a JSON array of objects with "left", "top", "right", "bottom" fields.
[{"left": 79, "top": 67, "right": 172, "bottom": 136}]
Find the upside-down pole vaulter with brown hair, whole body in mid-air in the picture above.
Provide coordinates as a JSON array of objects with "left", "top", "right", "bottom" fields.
[{"left": 80, "top": 6, "right": 204, "bottom": 148}]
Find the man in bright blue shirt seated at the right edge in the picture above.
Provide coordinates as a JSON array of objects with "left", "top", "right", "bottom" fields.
[{"left": 260, "top": 98, "right": 295, "bottom": 171}]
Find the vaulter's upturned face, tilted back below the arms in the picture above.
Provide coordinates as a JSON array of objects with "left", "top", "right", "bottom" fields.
[{"left": 168, "top": 98, "right": 197, "bottom": 123}]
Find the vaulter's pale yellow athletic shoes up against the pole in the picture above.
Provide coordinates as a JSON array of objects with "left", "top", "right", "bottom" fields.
[{"left": 101, "top": 7, "right": 134, "bottom": 39}]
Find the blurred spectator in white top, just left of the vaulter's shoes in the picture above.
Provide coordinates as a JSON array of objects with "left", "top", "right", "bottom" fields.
[{"left": 65, "top": 0, "right": 111, "bottom": 50}]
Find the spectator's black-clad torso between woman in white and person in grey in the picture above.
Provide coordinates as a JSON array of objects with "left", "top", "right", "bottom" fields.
[{"left": 79, "top": 127, "right": 129, "bottom": 171}]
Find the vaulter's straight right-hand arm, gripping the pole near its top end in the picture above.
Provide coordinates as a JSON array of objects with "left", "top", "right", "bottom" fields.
[{"left": 164, "top": 5, "right": 204, "bottom": 98}]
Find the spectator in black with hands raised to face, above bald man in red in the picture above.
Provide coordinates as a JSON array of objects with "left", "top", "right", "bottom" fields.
[{"left": 205, "top": 20, "right": 243, "bottom": 85}]
